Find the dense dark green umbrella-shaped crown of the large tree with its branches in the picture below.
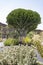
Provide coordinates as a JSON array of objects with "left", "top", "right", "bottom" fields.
[{"left": 7, "top": 9, "right": 41, "bottom": 36}]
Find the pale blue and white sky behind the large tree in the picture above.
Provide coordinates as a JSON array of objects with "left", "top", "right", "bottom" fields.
[{"left": 0, "top": 0, "right": 43, "bottom": 30}]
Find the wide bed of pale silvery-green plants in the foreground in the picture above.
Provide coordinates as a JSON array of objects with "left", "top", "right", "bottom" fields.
[{"left": 0, "top": 46, "right": 37, "bottom": 65}]
